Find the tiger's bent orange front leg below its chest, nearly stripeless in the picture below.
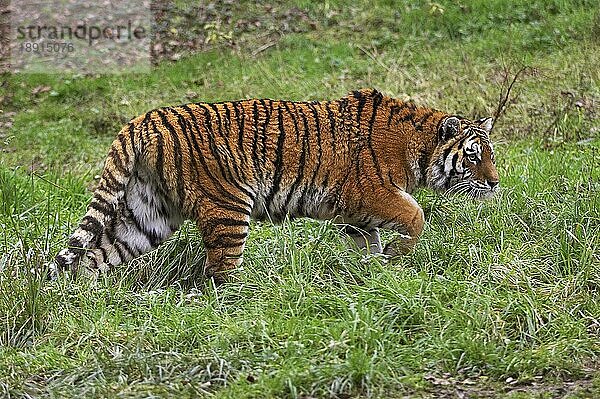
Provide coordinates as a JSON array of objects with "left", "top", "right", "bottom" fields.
[{"left": 344, "top": 190, "right": 425, "bottom": 257}]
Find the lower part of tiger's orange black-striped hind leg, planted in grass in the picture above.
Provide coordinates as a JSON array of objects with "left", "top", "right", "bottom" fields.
[{"left": 197, "top": 204, "right": 251, "bottom": 284}]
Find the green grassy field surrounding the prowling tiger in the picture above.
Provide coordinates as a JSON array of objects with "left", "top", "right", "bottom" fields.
[{"left": 0, "top": 0, "right": 600, "bottom": 399}]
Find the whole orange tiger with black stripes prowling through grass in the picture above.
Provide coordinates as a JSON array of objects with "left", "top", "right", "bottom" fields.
[{"left": 51, "top": 89, "right": 499, "bottom": 284}]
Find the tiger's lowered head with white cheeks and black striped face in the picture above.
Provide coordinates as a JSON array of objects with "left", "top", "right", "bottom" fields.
[{"left": 427, "top": 116, "right": 500, "bottom": 199}]
